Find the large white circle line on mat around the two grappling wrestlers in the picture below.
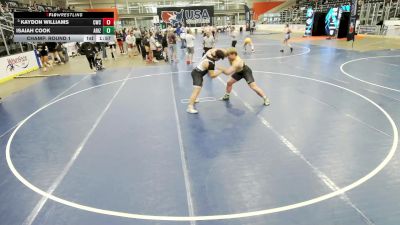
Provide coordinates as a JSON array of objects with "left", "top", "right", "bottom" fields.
[{"left": 6, "top": 71, "right": 398, "bottom": 221}]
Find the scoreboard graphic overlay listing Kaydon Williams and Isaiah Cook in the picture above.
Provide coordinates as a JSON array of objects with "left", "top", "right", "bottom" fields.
[{"left": 14, "top": 12, "right": 115, "bottom": 42}]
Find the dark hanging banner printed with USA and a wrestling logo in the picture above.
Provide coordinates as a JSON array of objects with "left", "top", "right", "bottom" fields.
[{"left": 157, "top": 6, "right": 214, "bottom": 27}]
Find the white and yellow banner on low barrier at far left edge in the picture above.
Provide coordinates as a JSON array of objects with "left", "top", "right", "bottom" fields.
[{"left": 0, "top": 51, "right": 39, "bottom": 82}]
